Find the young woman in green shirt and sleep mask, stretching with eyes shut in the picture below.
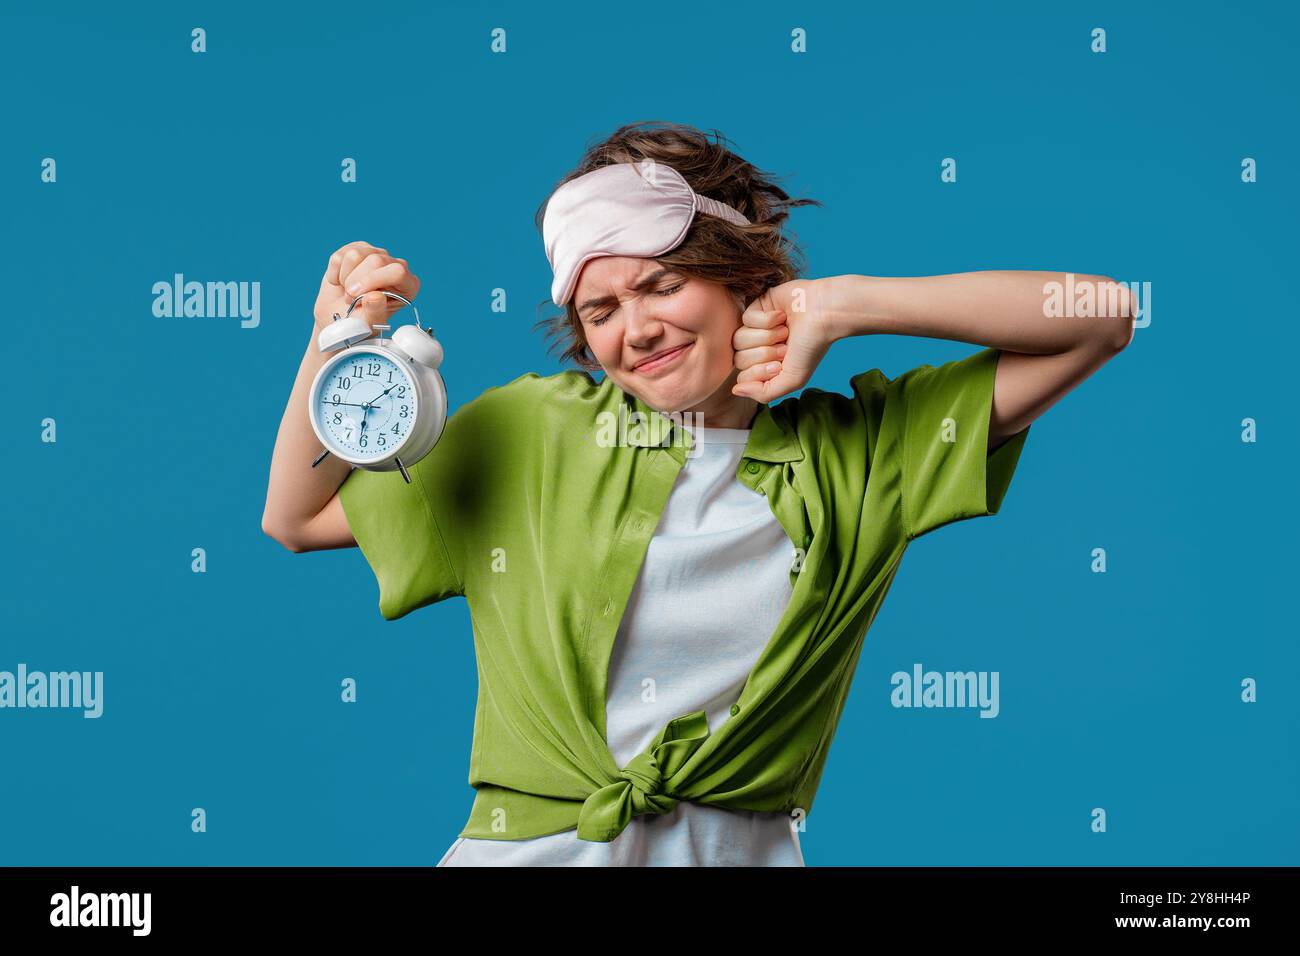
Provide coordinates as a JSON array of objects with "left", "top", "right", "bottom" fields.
[{"left": 263, "top": 124, "right": 1132, "bottom": 866}]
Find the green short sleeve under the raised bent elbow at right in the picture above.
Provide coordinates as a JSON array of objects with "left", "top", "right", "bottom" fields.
[{"left": 885, "top": 349, "right": 1030, "bottom": 540}]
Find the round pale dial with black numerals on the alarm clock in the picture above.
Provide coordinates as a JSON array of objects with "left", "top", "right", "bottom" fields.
[{"left": 312, "top": 351, "right": 417, "bottom": 459}]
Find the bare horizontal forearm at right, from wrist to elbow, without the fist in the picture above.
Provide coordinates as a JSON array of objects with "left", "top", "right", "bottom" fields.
[{"left": 816, "top": 272, "right": 1132, "bottom": 355}]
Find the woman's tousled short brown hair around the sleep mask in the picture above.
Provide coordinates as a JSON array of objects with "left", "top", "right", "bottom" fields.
[{"left": 534, "top": 121, "right": 822, "bottom": 371}]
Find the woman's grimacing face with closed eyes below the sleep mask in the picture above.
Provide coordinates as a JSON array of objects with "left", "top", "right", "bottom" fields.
[{"left": 573, "top": 256, "right": 758, "bottom": 428}]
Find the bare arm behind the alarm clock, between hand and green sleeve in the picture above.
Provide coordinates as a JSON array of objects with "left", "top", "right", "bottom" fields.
[{"left": 263, "top": 326, "right": 352, "bottom": 542}]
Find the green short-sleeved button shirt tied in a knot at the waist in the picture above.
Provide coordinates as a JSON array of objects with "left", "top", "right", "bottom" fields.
[{"left": 339, "top": 349, "right": 1030, "bottom": 842}]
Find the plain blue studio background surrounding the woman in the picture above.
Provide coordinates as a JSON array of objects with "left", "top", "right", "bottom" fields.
[{"left": 0, "top": 3, "right": 1300, "bottom": 865}]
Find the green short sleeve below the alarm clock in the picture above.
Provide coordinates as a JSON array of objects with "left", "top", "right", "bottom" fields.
[{"left": 338, "top": 408, "right": 468, "bottom": 620}]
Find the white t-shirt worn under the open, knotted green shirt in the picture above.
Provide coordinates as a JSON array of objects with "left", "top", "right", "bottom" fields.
[{"left": 438, "top": 427, "right": 803, "bottom": 866}]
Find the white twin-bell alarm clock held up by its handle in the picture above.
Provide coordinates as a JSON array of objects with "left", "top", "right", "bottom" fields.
[{"left": 308, "top": 290, "right": 447, "bottom": 484}]
